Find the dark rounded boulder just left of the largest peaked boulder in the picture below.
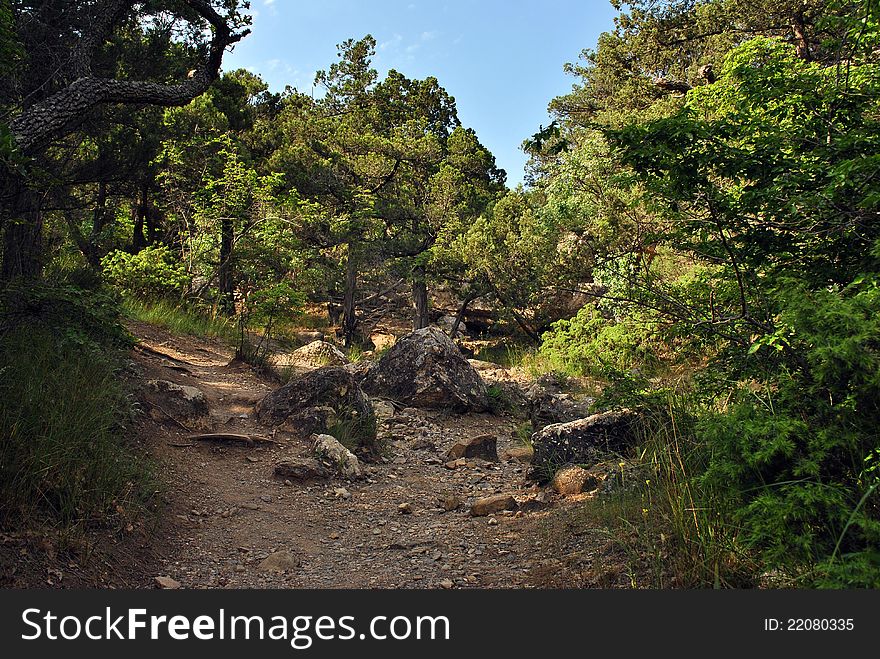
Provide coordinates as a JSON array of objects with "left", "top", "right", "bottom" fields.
[{"left": 256, "top": 366, "right": 378, "bottom": 455}]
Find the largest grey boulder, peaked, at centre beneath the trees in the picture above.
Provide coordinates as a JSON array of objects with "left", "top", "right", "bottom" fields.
[{"left": 363, "top": 327, "right": 489, "bottom": 412}]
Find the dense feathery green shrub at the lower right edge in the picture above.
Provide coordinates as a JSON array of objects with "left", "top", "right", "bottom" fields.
[{"left": 699, "top": 277, "right": 880, "bottom": 587}]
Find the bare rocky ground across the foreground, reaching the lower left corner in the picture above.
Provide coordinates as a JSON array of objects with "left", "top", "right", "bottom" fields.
[{"left": 0, "top": 323, "right": 629, "bottom": 589}]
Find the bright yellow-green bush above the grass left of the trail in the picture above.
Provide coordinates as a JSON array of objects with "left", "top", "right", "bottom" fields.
[{"left": 101, "top": 245, "right": 189, "bottom": 301}]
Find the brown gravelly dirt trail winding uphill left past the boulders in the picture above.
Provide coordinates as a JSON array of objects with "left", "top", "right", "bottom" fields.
[{"left": 130, "top": 324, "right": 620, "bottom": 588}]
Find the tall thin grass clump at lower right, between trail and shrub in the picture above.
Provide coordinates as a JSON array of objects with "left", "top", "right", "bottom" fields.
[{"left": 587, "top": 397, "right": 759, "bottom": 588}]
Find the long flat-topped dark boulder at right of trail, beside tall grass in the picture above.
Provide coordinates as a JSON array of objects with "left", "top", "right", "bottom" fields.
[{"left": 529, "top": 409, "right": 641, "bottom": 482}]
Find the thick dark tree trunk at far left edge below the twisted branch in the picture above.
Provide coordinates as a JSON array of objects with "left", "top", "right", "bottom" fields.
[{"left": 0, "top": 183, "right": 43, "bottom": 282}]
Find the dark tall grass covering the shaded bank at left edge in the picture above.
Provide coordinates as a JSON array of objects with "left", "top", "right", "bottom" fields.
[{"left": 0, "top": 324, "right": 155, "bottom": 528}]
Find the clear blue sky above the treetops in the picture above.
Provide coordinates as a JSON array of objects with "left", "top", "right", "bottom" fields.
[{"left": 223, "top": 0, "right": 616, "bottom": 187}]
